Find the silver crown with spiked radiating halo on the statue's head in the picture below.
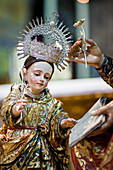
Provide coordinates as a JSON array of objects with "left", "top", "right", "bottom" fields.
[{"left": 17, "top": 12, "right": 72, "bottom": 71}]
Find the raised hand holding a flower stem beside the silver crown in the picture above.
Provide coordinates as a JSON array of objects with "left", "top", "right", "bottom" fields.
[{"left": 68, "top": 38, "right": 104, "bottom": 68}]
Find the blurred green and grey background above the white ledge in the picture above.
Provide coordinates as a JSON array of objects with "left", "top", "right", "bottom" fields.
[{"left": 0, "top": 0, "right": 113, "bottom": 84}]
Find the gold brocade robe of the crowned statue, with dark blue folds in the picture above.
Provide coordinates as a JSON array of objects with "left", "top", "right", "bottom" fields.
[{"left": 0, "top": 85, "right": 70, "bottom": 170}]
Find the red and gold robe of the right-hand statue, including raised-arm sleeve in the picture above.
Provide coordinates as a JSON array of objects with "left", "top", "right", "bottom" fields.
[{"left": 71, "top": 56, "right": 113, "bottom": 170}]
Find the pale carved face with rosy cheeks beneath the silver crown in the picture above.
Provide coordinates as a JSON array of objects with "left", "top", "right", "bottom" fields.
[{"left": 25, "top": 62, "right": 52, "bottom": 95}]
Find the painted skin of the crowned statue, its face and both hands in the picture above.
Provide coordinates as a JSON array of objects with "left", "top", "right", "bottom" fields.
[{"left": 12, "top": 62, "right": 76, "bottom": 129}]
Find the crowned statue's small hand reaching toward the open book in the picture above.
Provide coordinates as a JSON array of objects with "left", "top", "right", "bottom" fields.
[{"left": 60, "top": 118, "right": 77, "bottom": 129}]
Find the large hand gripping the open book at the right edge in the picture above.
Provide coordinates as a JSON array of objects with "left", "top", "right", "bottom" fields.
[{"left": 90, "top": 100, "right": 113, "bottom": 136}]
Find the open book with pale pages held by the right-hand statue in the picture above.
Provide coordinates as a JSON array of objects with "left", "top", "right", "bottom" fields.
[{"left": 69, "top": 97, "right": 107, "bottom": 148}]
